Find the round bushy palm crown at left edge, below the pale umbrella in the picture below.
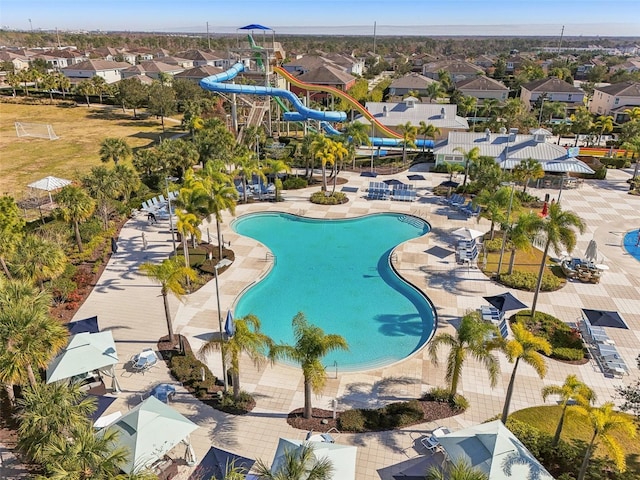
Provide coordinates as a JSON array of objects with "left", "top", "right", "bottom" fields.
[{"left": 11, "top": 234, "right": 68, "bottom": 290}]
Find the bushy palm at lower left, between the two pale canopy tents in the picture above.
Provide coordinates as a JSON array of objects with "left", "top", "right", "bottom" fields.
[{"left": 18, "top": 382, "right": 96, "bottom": 462}]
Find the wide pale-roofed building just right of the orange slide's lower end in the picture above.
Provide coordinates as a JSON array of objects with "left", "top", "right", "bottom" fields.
[{"left": 356, "top": 97, "right": 469, "bottom": 138}]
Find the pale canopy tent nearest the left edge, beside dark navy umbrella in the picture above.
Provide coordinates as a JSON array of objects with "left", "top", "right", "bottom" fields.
[{"left": 47, "top": 331, "right": 120, "bottom": 392}]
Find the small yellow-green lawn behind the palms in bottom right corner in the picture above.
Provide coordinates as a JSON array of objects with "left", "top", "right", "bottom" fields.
[{"left": 510, "top": 406, "right": 640, "bottom": 472}]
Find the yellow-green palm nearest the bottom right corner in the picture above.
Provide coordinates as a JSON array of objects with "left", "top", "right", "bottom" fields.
[{"left": 575, "top": 402, "right": 636, "bottom": 480}]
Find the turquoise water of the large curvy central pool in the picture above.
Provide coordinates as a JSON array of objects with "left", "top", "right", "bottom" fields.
[{"left": 232, "top": 213, "right": 435, "bottom": 371}]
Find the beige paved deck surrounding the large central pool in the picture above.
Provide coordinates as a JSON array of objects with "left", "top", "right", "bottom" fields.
[{"left": 70, "top": 170, "right": 640, "bottom": 479}]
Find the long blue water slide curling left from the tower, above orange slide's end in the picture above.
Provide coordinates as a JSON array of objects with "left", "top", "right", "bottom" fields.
[{"left": 200, "top": 63, "right": 347, "bottom": 122}]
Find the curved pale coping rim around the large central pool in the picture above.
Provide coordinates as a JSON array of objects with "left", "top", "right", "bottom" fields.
[{"left": 229, "top": 210, "right": 438, "bottom": 376}]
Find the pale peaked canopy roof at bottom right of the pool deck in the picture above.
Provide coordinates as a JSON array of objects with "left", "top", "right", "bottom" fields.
[{"left": 438, "top": 420, "right": 553, "bottom": 480}]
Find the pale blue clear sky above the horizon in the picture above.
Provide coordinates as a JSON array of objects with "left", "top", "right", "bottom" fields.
[{"left": 0, "top": 0, "right": 640, "bottom": 37}]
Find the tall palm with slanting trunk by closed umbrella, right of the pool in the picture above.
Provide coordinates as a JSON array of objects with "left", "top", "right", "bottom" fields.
[{"left": 530, "top": 203, "right": 585, "bottom": 318}]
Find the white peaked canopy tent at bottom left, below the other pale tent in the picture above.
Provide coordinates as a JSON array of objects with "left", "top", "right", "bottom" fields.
[{"left": 107, "top": 396, "right": 198, "bottom": 473}]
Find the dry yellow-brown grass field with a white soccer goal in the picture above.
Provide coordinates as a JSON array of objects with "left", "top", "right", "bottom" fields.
[{"left": 0, "top": 103, "right": 181, "bottom": 200}]
